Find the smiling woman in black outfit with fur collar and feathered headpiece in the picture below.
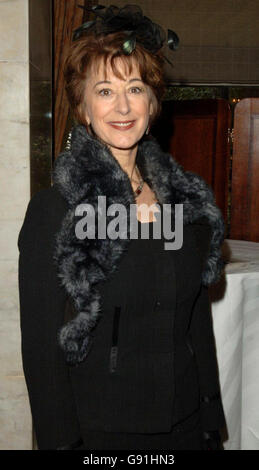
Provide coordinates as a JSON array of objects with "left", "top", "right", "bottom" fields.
[{"left": 18, "top": 6, "right": 228, "bottom": 450}]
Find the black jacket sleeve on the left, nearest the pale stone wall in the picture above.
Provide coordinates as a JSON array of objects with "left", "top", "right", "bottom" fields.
[{"left": 18, "top": 188, "right": 81, "bottom": 449}]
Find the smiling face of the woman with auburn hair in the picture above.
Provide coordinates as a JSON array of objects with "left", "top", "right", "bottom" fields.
[{"left": 82, "top": 58, "right": 153, "bottom": 156}]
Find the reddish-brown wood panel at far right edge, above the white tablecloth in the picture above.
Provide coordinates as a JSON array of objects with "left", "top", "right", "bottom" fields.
[{"left": 230, "top": 98, "right": 259, "bottom": 242}]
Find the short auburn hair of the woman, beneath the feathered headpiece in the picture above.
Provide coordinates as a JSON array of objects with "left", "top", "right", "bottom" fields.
[{"left": 63, "top": 32, "right": 168, "bottom": 127}]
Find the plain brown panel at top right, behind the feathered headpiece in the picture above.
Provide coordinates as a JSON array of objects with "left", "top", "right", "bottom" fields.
[{"left": 100, "top": 0, "right": 259, "bottom": 85}]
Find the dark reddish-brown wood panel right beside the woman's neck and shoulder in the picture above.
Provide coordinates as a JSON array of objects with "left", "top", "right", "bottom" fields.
[{"left": 152, "top": 99, "right": 231, "bottom": 224}]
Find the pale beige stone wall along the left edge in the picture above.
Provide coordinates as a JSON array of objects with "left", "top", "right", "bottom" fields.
[{"left": 0, "top": 0, "right": 32, "bottom": 450}]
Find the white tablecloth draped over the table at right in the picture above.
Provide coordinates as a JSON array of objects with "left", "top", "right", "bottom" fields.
[{"left": 210, "top": 240, "right": 259, "bottom": 450}]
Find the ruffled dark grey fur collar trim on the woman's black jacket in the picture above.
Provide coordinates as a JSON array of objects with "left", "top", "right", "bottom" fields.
[{"left": 52, "top": 125, "right": 225, "bottom": 365}]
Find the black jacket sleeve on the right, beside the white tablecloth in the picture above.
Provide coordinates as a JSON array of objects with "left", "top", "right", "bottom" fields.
[{"left": 190, "top": 225, "right": 226, "bottom": 431}]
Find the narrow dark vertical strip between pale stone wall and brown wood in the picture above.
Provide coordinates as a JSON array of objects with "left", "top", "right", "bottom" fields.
[{"left": 29, "top": 0, "right": 52, "bottom": 196}]
